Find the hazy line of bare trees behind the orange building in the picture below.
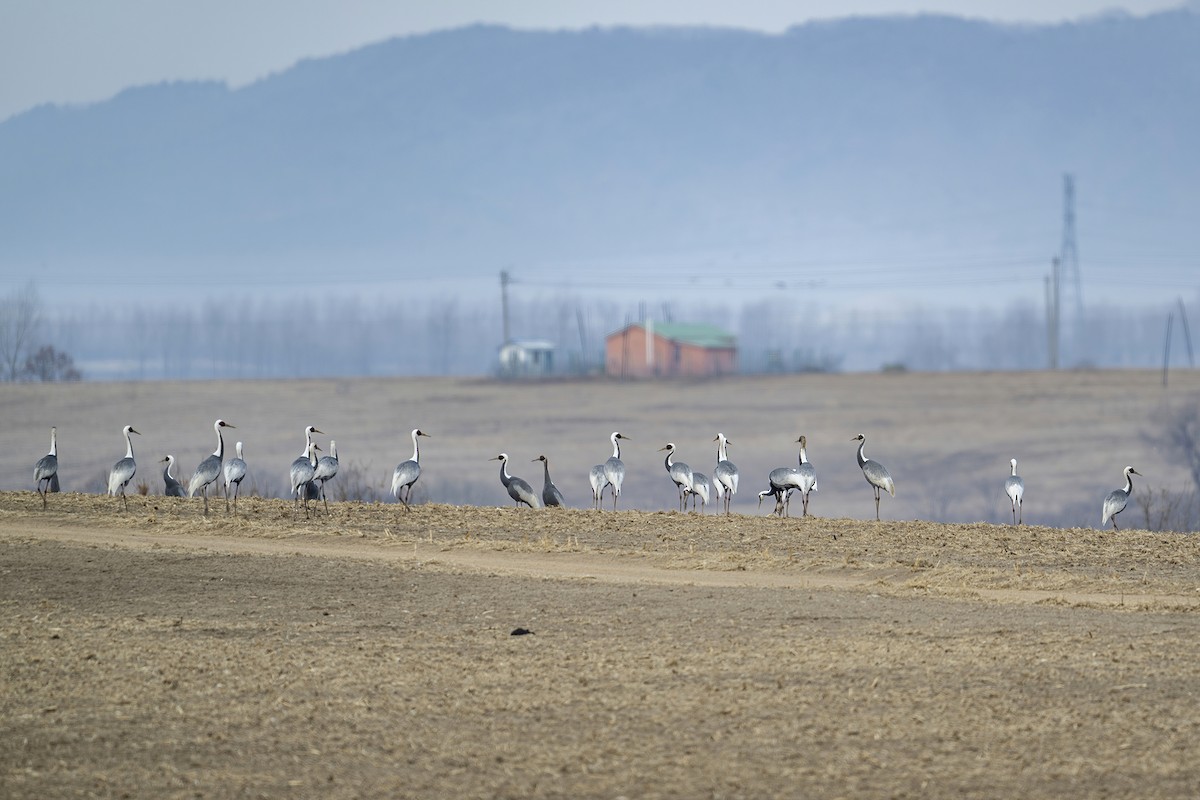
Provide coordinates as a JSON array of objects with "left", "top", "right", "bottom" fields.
[{"left": 18, "top": 287, "right": 1200, "bottom": 379}]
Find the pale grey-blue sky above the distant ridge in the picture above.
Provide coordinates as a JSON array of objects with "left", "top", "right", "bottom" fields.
[{"left": 0, "top": 0, "right": 1200, "bottom": 120}]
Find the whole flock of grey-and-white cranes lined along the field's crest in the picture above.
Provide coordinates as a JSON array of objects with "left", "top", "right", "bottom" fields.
[{"left": 34, "top": 420, "right": 1141, "bottom": 529}]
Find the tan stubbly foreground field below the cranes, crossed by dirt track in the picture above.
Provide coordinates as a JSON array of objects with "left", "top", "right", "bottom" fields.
[{"left": 7, "top": 492, "right": 1200, "bottom": 799}]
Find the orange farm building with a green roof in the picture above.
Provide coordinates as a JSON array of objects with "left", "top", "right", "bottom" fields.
[{"left": 605, "top": 321, "right": 738, "bottom": 378}]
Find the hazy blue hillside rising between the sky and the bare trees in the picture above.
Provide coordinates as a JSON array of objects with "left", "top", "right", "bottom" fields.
[{"left": 0, "top": 11, "right": 1200, "bottom": 299}]
